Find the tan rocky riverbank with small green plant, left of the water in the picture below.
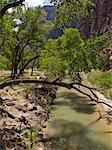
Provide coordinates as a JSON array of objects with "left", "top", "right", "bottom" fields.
[{"left": 0, "top": 82, "right": 56, "bottom": 150}]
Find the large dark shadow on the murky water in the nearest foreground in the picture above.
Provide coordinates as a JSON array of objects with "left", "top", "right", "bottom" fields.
[{"left": 45, "top": 119, "right": 110, "bottom": 150}]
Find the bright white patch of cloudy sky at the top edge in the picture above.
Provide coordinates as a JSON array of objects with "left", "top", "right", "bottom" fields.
[{"left": 25, "top": 0, "right": 50, "bottom": 7}]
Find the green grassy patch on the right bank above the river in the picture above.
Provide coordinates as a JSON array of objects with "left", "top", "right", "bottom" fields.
[{"left": 87, "top": 70, "right": 112, "bottom": 99}]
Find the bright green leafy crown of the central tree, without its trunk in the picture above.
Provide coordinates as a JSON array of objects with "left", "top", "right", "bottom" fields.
[{"left": 40, "top": 28, "right": 107, "bottom": 78}]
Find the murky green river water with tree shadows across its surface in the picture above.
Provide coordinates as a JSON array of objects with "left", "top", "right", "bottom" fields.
[{"left": 45, "top": 88, "right": 112, "bottom": 150}]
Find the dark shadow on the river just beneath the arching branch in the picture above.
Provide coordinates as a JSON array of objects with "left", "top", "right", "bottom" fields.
[{"left": 55, "top": 92, "right": 96, "bottom": 114}]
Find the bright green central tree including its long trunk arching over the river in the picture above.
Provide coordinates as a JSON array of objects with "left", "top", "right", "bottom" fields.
[{"left": 0, "top": 28, "right": 112, "bottom": 107}]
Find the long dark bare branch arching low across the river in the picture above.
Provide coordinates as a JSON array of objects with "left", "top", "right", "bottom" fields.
[{"left": 0, "top": 79, "right": 112, "bottom": 108}]
